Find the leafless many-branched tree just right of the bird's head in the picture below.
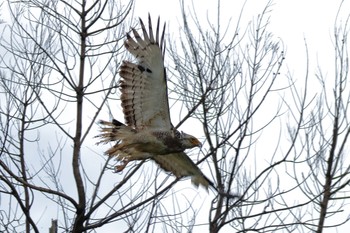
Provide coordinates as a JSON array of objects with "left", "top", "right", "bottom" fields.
[{"left": 167, "top": 2, "right": 296, "bottom": 232}]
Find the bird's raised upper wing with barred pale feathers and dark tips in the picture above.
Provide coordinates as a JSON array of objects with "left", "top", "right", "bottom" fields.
[{"left": 119, "top": 16, "right": 172, "bottom": 130}]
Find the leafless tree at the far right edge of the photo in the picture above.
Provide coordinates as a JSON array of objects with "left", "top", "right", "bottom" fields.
[{"left": 291, "top": 2, "right": 350, "bottom": 233}]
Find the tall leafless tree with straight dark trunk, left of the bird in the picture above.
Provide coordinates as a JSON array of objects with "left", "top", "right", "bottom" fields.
[{"left": 0, "top": 0, "right": 172, "bottom": 232}]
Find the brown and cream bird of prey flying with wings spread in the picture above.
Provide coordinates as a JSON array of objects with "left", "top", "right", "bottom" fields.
[{"left": 99, "top": 15, "right": 212, "bottom": 189}]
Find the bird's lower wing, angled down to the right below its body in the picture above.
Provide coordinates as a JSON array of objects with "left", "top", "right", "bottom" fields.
[{"left": 152, "top": 152, "right": 211, "bottom": 189}]
